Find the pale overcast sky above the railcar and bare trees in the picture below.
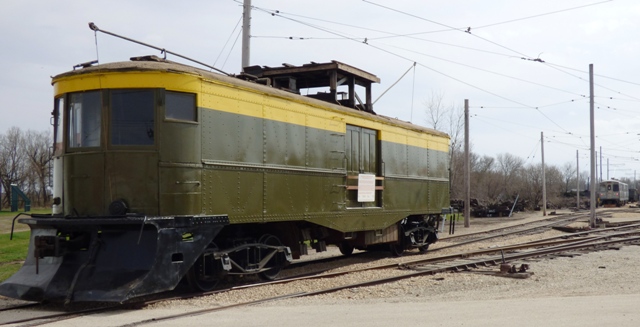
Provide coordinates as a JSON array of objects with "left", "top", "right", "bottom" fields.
[{"left": 0, "top": 0, "right": 640, "bottom": 178}]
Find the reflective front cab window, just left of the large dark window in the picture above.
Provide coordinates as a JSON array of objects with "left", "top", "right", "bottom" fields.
[{"left": 67, "top": 91, "right": 101, "bottom": 148}]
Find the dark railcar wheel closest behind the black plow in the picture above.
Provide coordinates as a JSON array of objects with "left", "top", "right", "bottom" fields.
[{"left": 187, "top": 243, "right": 223, "bottom": 292}]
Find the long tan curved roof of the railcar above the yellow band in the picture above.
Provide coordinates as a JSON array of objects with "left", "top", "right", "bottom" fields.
[{"left": 52, "top": 56, "right": 449, "bottom": 138}]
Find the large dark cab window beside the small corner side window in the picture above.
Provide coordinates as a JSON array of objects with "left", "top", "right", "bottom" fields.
[{"left": 111, "top": 90, "right": 155, "bottom": 145}]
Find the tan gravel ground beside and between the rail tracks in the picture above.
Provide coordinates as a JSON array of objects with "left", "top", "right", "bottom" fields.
[{"left": 3, "top": 209, "right": 640, "bottom": 327}]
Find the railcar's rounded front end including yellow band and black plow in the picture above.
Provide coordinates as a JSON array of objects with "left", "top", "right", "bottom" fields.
[{"left": 0, "top": 64, "right": 229, "bottom": 302}]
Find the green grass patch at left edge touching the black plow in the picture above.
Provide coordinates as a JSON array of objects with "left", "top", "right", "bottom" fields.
[{"left": 0, "top": 232, "right": 31, "bottom": 282}]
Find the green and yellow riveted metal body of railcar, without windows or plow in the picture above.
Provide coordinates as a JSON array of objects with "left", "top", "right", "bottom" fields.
[{"left": 53, "top": 61, "right": 449, "bottom": 232}]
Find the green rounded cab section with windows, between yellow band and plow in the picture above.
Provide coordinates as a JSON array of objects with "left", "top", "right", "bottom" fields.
[{"left": 53, "top": 81, "right": 201, "bottom": 216}]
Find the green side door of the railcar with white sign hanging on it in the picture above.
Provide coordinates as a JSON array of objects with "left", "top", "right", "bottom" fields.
[{"left": 345, "top": 125, "right": 381, "bottom": 208}]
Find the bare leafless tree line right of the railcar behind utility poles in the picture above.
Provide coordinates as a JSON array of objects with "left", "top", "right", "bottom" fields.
[{"left": 424, "top": 92, "right": 636, "bottom": 209}]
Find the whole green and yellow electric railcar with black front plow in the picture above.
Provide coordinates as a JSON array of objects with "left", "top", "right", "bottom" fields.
[{"left": 0, "top": 56, "right": 449, "bottom": 301}]
